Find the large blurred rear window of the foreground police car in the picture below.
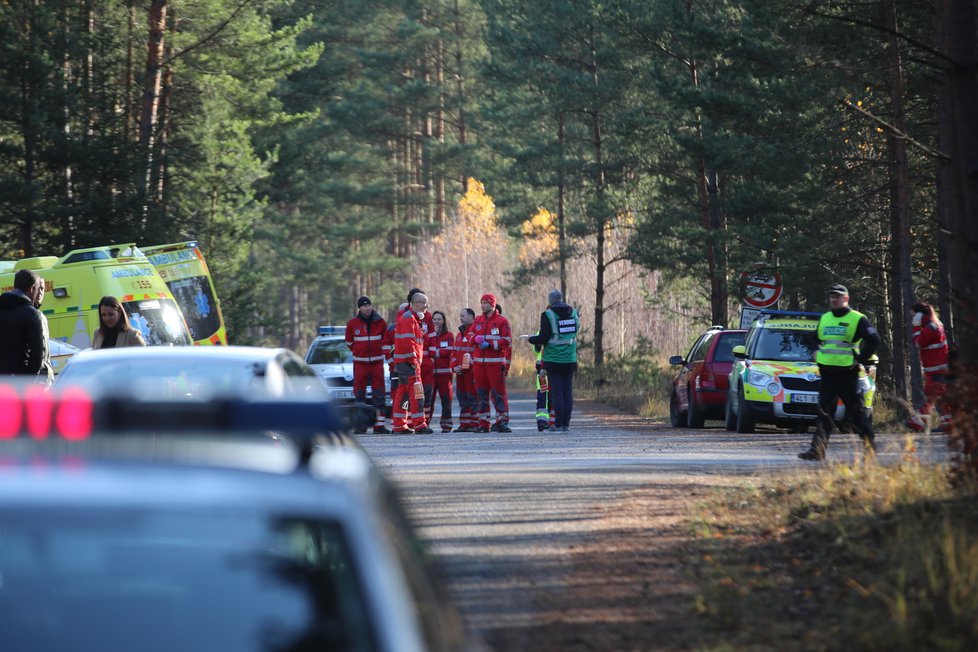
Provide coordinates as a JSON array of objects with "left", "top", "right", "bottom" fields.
[{"left": 0, "top": 508, "right": 374, "bottom": 652}]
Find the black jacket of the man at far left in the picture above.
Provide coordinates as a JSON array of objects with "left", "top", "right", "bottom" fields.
[{"left": 0, "top": 290, "right": 50, "bottom": 375}]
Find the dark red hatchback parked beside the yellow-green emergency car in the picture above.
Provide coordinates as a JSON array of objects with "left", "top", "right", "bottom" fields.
[{"left": 669, "top": 326, "right": 747, "bottom": 428}]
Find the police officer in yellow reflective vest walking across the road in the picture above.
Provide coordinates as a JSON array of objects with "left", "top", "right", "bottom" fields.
[{"left": 798, "top": 285, "right": 880, "bottom": 460}]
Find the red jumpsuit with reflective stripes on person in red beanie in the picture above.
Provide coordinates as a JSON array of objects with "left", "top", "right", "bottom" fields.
[{"left": 471, "top": 311, "right": 513, "bottom": 429}]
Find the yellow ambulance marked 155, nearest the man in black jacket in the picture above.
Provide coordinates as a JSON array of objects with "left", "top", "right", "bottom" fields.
[{"left": 0, "top": 243, "right": 193, "bottom": 349}]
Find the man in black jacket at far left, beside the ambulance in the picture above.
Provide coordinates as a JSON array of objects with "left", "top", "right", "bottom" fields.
[{"left": 0, "top": 269, "right": 54, "bottom": 383}]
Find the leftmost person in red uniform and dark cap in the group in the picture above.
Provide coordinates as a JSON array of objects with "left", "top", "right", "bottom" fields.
[{"left": 346, "top": 297, "right": 390, "bottom": 434}]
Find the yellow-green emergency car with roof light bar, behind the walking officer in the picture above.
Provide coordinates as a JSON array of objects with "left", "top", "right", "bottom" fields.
[{"left": 724, "top": 310, "right": 876, "bottom": 433}]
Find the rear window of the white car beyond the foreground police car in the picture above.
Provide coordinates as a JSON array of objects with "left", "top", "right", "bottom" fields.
[{"left": 58, "top": 355, "right": 266, "bottom": 398}]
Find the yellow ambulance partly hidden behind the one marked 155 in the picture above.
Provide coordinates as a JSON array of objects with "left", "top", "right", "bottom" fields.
[{"left": 142, "top": 241, "right": 228, "bottom": 346}]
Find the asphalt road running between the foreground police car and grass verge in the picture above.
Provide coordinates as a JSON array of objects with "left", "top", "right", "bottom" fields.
[{"left": 360, "top": 394, "right": 944, "bottom": 650}]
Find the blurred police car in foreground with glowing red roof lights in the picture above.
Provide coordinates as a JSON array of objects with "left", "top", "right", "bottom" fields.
[{"left": 0, "top": 384, "right": 474, "bottom": 652}]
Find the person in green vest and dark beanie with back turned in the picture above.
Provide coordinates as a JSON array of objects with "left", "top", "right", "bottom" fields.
[{"left": 529, "top": 290, "right": 581, "bottom": 432}]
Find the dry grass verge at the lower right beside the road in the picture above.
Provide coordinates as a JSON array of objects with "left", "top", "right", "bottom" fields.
[{"left": 689, "top": 449, "right": 978, "bottom": 652}]
